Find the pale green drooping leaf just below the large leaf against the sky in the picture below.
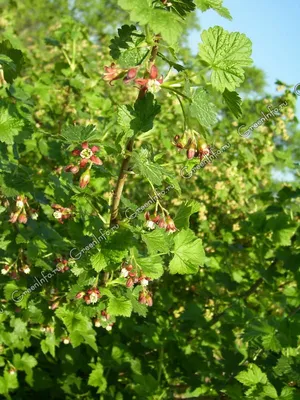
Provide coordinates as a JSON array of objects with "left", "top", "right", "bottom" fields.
[{"left": 189, "top": 89, "right": 217, "bottom": 128}]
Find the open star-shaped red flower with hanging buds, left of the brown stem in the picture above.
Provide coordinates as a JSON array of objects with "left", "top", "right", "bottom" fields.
[{"left": 65, "top": 142, "right": 103, "bottom": 189}]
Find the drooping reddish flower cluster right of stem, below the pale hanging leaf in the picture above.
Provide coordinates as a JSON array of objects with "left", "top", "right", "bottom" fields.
[{"left": 174, "top": 129, "right": 211, "bottom": 160}]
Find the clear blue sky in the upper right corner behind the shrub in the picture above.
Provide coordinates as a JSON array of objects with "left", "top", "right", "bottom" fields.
[{"left": 190, "top": 0, "right": 300, "bottom": 104}]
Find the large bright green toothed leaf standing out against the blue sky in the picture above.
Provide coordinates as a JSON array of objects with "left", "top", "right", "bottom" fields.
[{"left": 200, "top": 26, "right": 252, "bottom": 93}]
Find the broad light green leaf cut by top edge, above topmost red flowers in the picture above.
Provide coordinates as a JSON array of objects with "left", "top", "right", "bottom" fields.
[{"left": 118, "top": 0, "right": 183, "bottom": 46}]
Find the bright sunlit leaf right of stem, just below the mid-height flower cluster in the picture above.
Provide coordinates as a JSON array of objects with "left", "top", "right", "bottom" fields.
[{"left": 169, "top": 230, "right": 205, "bottom": 274}]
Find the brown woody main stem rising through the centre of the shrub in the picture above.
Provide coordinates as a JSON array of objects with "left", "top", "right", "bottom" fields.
[{"left": 110, "top": 42, "right": 159, "bottom": 226}]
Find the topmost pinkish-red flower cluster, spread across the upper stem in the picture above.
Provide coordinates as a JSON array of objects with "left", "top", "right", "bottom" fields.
[{"left": 103, "top": 63, "right": 163, "bottom": 95}]
